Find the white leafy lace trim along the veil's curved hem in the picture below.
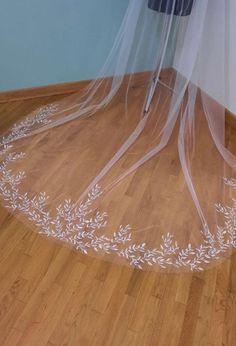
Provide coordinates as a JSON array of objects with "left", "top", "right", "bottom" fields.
[{"left": 0, "top": 106, "right": 236, "bottom": 271}]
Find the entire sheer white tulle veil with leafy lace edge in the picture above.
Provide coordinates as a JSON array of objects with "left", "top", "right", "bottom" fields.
[{"left": 0, "top": 0, "right": 236, "bottom": 271}]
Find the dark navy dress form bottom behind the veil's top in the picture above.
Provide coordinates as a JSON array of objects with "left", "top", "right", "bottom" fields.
[{"left": 148, "top": 0, "right": 195, "bottom": 16}]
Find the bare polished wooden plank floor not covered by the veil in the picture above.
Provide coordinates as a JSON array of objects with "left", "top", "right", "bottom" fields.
[{"left": 0, "top": 92, "right": 236, "bottom": 346}]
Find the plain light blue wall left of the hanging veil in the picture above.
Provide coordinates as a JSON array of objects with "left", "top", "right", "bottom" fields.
[{"left": 0, "top": 0, "right": 128, "bottom": 91}]
